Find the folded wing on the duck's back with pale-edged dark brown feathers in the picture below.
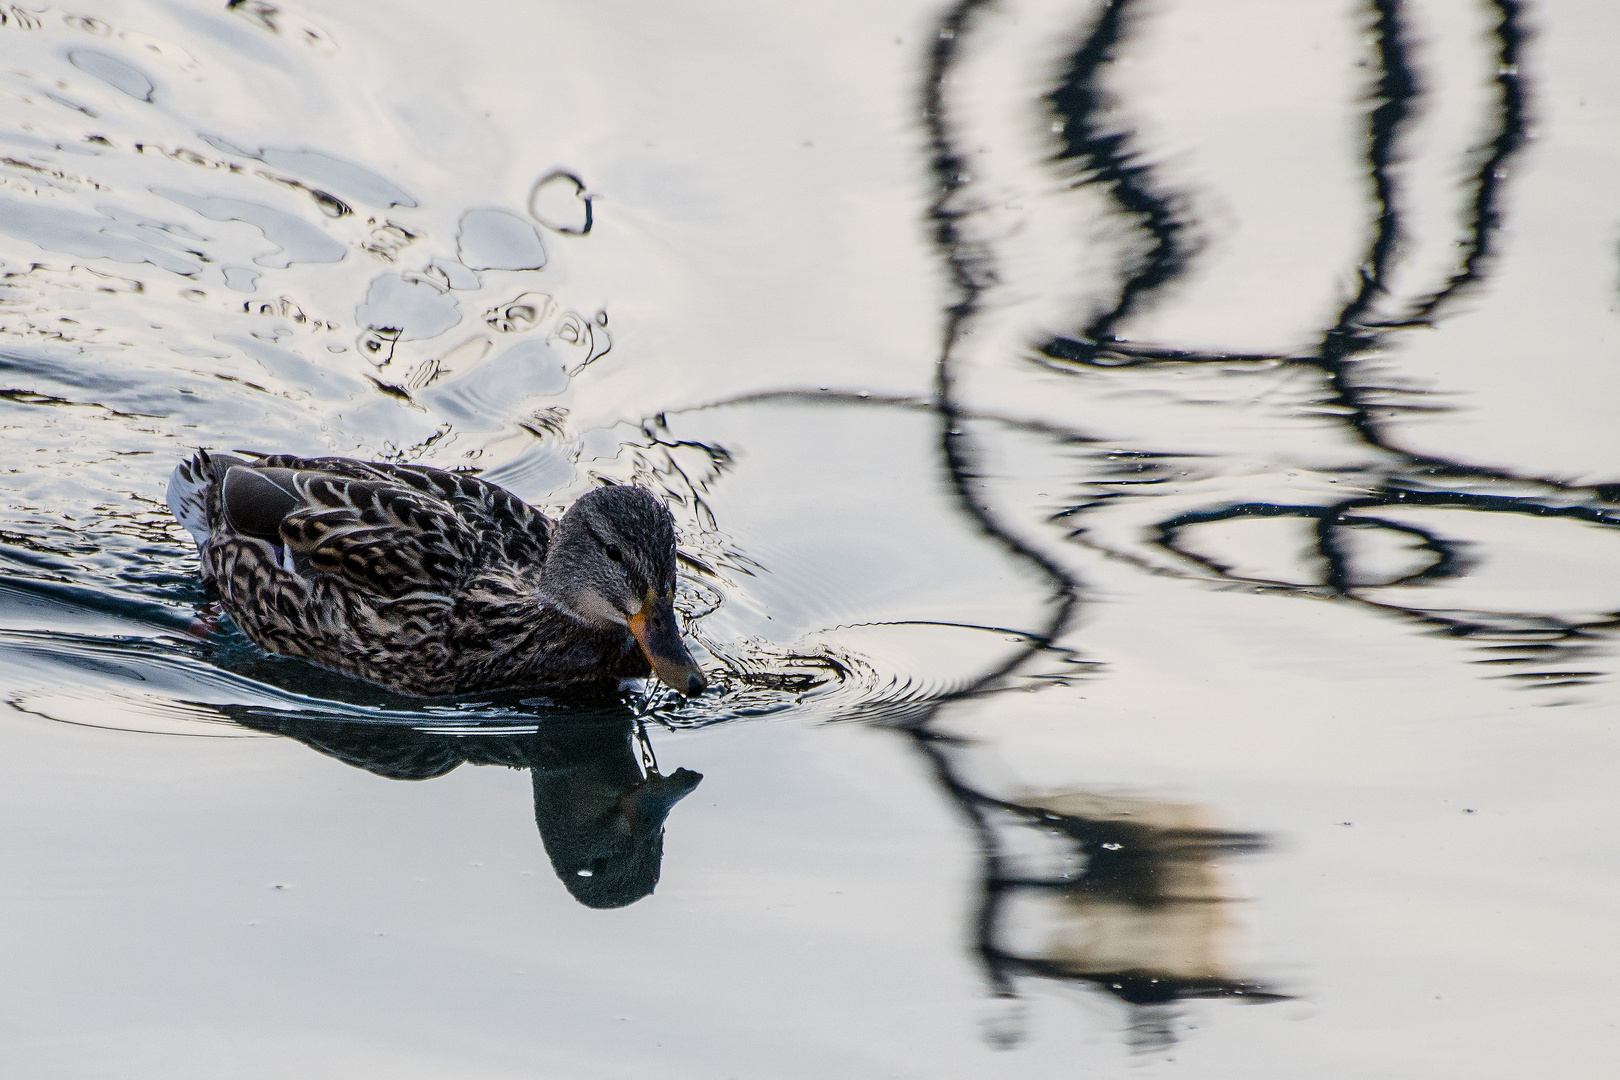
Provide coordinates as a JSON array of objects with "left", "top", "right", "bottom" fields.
[{"left": 211, "top": 460, "right": 483, "bottom": 599}]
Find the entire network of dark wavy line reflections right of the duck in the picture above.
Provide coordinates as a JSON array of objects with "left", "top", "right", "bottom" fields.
[{"left": 913, "top": 0, "right": 1620, "bottom": 1042}]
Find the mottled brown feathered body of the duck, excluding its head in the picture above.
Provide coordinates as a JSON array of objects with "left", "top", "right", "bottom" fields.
[{"left": 177, "top": 453, "right": 650, "bottom": 695}]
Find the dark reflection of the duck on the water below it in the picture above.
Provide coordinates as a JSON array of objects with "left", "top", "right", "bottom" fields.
[{"left": 233, "top": 711, "right": 703, "bottom": 908}]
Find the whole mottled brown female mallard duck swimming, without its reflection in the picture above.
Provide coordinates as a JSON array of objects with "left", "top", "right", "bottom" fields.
[{"left": 168, "top": 450, "right": 705, "bottom": 695}]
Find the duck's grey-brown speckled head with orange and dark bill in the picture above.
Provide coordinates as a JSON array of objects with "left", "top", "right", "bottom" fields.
[{"left": 541, "top": 484, "right": 708, "bottom": 695}]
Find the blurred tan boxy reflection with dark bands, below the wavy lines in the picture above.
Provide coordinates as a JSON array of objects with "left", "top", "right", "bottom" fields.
[{"left": 912, "top": 729, "right": 1286, "bottom": 1049}]
